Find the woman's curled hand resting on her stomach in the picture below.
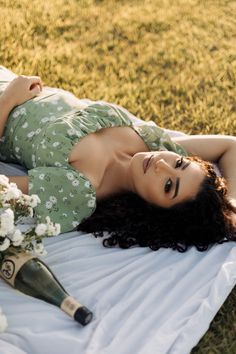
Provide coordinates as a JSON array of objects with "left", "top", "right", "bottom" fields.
[{"left": 2, "top": 75, "right": 43, "bottom": 109}]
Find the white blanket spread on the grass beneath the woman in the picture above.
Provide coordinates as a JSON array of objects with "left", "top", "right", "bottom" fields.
[{"left": 0, "top": 68, "right": 236, "bottom": 354}]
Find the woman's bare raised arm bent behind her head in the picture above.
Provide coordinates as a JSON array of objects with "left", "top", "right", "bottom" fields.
[{"left": 172, "top": 135, "right": 236, "bottom": 201}]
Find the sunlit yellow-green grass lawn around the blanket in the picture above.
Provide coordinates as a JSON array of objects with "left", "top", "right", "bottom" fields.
[{"left": 0, "top": 0, "right": 236, "bottom": 354}]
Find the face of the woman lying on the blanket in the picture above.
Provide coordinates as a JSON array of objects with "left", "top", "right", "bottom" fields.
[{"left": 130, "top": 151, "right": 205, "bottom": 208}]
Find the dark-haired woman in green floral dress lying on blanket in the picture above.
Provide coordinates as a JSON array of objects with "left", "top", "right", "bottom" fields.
[{"left": 0, "top": 76, "right": 236, "bottom": 251}]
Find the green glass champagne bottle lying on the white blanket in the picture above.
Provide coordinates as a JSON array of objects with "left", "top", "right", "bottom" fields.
[{"left": 0, "top": 249, "right": 93, "bottom": 326}]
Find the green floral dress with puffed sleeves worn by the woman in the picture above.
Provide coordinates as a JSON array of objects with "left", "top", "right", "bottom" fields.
[{"left": 0, "top": 81, "right": 186, "bottom": 232}]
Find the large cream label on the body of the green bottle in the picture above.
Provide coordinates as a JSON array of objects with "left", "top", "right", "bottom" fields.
[{"left": 0, "top": 250, "right": 34, "bottom": 287}]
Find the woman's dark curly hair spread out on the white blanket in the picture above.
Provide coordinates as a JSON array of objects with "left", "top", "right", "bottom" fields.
[{"left": 78, "top": 156, "right": 236, "bottom": 252}]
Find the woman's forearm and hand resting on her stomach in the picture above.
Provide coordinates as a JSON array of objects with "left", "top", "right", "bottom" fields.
[{"left": 0, "top": 76, "right": 42, "bottom": 138}]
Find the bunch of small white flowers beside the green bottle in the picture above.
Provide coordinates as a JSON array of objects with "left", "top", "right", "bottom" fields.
[{"left": 0, "top": 175, "right": 60, "bottom": 332}]
